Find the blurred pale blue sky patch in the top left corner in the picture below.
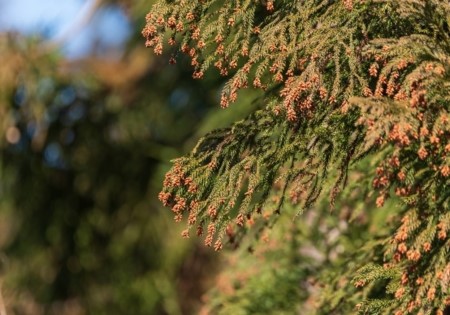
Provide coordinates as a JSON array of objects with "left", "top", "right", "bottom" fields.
[{"left": 0, "top": 0, "right": 131, "bottom": 58}]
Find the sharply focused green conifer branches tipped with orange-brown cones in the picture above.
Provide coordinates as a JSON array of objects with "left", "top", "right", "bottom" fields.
[{"left": 142, "top": 0, "right": 450, "bottom": 315}]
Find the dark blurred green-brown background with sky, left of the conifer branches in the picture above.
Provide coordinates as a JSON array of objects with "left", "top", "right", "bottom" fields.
[{"left": 0, "top": 0, "right": 251, "bottom": 315}]
